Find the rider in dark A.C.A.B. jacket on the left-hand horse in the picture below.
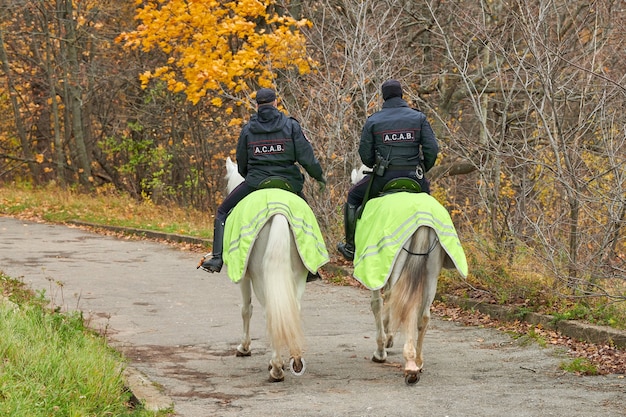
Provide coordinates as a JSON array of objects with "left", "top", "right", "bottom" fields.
[{"left": 202, "top": 88, "right": 326, "bottom": 272}]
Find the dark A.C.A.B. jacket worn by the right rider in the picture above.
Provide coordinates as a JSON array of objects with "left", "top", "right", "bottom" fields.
[{"left": 359, "top": 97, "right": 439, "bottom": 171}]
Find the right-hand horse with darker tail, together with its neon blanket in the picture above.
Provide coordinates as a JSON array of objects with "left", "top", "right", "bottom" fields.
[{"left": 352, "top": 167, "right": 468, "bottom": 384}]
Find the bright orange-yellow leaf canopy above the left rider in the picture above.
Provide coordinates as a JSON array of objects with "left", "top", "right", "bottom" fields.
[{"left": 117, "top": 0, "right": 312, "bottom": 107}]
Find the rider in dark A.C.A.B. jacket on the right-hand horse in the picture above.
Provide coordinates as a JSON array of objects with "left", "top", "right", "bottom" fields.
[{"left": 337, "top": 80, "right": 439, "bottom": 261}]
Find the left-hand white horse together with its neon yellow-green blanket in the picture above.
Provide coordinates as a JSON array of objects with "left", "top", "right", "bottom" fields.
[{"left": 202, "top": 158, "right": 329, "bottom": 382}]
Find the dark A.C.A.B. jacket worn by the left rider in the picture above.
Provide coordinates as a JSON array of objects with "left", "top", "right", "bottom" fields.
[{"left": 237, "top": 105, "right": 324, "bottom": 193}]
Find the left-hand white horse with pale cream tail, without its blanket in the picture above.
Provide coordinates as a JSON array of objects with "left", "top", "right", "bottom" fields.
[{"left": 226, "top": 158, "right": 308, "bottom": 382}]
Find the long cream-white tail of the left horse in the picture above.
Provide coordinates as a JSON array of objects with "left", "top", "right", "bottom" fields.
[{"left": 263, "top": 214, "right": 304, "bottom": 356}]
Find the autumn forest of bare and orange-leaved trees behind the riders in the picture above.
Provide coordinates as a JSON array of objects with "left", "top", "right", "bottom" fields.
[{"left": 0, "top": 0, "right": 626, "bottom": 326}]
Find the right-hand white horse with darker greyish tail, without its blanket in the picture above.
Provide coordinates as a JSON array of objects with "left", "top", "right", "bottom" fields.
[{"left": 352, "top": 166, "right": 464, "bottom": 385}]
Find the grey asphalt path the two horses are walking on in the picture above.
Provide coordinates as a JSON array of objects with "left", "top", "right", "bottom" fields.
[{"left": 0, "top": 217, "right": 626, "bottom": 417}]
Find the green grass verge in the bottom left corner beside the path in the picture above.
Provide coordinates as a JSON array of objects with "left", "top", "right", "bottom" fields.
[{"left": 0, "top": 272, "right": 165, "bottom": 417}]
